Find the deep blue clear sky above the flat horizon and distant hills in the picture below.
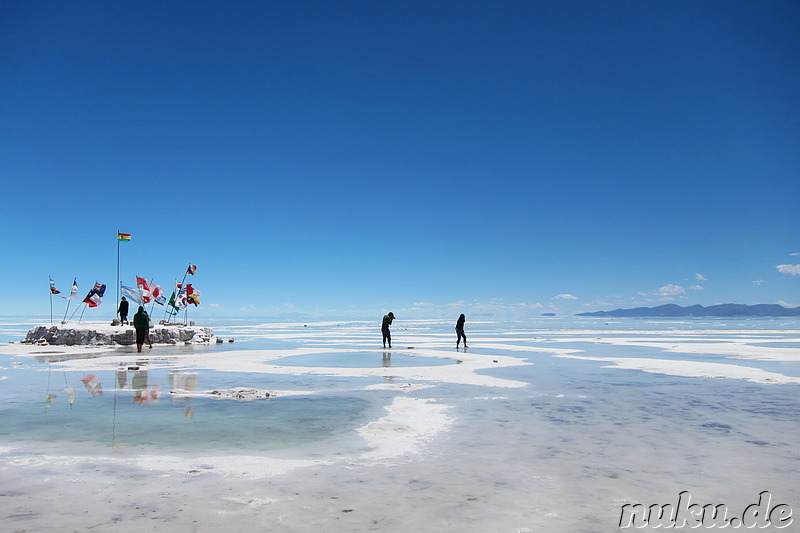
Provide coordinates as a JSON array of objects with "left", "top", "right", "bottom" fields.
[{"left": 0, "top": 0, "right": 800, "bottom": 318}]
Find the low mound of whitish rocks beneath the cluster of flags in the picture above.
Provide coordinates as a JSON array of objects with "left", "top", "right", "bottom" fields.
[{"left": 20, "top": 325, "right": 214, "bottom": 346}]
